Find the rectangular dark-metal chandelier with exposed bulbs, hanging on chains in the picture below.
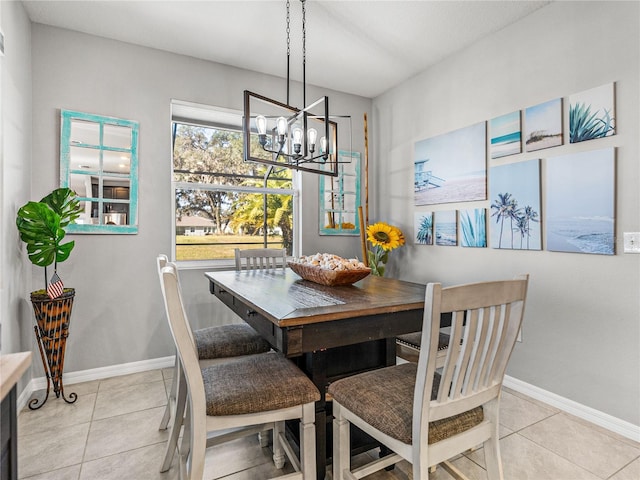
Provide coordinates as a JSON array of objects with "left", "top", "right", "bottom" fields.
[{"left": 243, "top": 0, "right": 350, "bottom": 176}]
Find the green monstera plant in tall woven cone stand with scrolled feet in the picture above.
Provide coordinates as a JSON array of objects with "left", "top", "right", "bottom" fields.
[{"left": 16, "top": 188, "right": 82, "bottom": 410}]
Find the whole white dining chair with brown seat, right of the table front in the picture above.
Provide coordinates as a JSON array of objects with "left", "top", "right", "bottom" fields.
[{"left": 329, "top": 275, "right": 529, "bottom": 480}]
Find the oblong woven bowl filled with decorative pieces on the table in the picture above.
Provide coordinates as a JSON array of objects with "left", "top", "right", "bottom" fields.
[{"left": 287, "top": 253, "right": 371, "bottom": 287}]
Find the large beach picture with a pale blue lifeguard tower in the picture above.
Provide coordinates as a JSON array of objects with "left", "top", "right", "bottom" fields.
[{"left": 414, "top": 122, "right": 487, "bottom": 205}]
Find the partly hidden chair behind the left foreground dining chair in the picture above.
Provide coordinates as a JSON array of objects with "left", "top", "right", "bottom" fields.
[{"left": 156, "top": 254, "right": 271, "bottom": 472}]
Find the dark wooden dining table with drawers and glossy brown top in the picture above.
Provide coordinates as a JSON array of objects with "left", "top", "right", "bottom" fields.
[{"left": 205, "top": 268, "right": 426, "bottom": 479}]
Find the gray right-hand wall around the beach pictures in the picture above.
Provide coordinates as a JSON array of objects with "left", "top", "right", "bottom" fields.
[{"left": 371, "top": 2, "right": 640, "bottom": 425}]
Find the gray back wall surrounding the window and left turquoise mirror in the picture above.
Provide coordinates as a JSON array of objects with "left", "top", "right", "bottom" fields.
[{"left": 23, "top": 24, "right": 371, "bottom": 376}]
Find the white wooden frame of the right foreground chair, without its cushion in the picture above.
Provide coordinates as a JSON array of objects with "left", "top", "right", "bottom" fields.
[{"left": 333, "top": 275, "right": 528, "bottom": 480}]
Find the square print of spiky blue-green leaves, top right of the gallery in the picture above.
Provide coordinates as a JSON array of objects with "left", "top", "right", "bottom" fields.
[{"left": 569, "top": 83, "right": 616, "bottom": 143}]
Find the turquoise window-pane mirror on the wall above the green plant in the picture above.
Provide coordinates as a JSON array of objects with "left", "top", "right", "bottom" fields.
[{"left": 60, "top": 110, "right": 138, "bottom": 234}]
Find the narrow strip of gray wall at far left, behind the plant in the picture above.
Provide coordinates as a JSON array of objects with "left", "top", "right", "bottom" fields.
[{"left": 0, "top": 2, "right": 35, "bottom": 391}]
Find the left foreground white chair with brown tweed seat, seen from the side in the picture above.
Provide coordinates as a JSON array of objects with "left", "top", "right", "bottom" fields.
[{"left": 161, "top": 263, "right": 320, "bottom": 480}]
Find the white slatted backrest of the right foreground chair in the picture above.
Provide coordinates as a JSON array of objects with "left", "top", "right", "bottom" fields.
[{"left": 414, "top": 276, "right": 528, "bottom": 430}]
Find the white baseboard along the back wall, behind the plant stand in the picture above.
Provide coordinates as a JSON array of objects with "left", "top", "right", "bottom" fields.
[{"left": 16, "top": 355, "right": 175, "bottom": 411}]
